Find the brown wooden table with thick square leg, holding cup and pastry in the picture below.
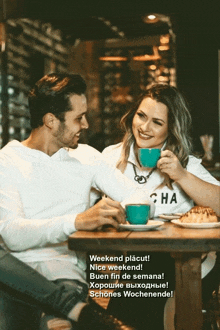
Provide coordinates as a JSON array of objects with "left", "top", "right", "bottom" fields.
[{"left": 68, "top": 222, "right": 220, "bottom": 330}]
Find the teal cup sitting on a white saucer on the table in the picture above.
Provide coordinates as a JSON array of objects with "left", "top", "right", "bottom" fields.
[{"left": 125, "top": 204, "right": 150, "bottom": 225}]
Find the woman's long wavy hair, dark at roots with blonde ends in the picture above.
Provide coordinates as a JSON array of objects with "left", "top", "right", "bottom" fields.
[{"left": 117, "top": 84, "right": 192, "bottom": 189}]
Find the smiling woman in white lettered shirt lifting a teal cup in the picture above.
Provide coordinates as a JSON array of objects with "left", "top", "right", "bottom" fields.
[{"left": 103, "top": 84, "right": 220, "bottom": 330}]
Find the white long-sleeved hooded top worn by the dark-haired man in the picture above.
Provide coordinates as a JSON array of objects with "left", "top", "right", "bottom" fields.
[{"left": 0, "top": 140, "right": 153, "bottom": 280}]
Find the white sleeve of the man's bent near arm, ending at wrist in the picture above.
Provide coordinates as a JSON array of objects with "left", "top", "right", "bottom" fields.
[{"left": 0, "top": 167, "right": 76, "bottom": 251}]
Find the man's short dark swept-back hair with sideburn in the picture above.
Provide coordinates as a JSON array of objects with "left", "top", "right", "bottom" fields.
[{"left": 28, "top": 73, "right": 86, "bottom": 129}]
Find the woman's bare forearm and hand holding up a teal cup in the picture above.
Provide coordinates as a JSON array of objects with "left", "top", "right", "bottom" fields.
[{"left": 157, "top": 150, "right": 220, "bottom": 216}]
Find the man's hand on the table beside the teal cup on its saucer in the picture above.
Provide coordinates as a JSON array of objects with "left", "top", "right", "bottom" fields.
[{"left": 75, "top": 198, "right": 126, "bottom": 230}]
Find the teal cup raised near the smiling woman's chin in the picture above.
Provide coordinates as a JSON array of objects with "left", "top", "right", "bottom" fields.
[{"left": 138, "top": 148, "right": 161, "bottom": 167}]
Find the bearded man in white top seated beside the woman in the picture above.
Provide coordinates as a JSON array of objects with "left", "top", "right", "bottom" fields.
[{"left": 0, "top": 74, "right": 153, "bottom": 330}]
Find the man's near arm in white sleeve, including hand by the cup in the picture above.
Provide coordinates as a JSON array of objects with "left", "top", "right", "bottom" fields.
[{"left": 0, "top": 175, "right": 125, "bottom": 251}]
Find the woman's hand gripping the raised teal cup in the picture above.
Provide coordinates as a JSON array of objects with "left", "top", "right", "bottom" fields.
[{"left": 157, "top": 150, "right": 187, "bottom": 182}]
